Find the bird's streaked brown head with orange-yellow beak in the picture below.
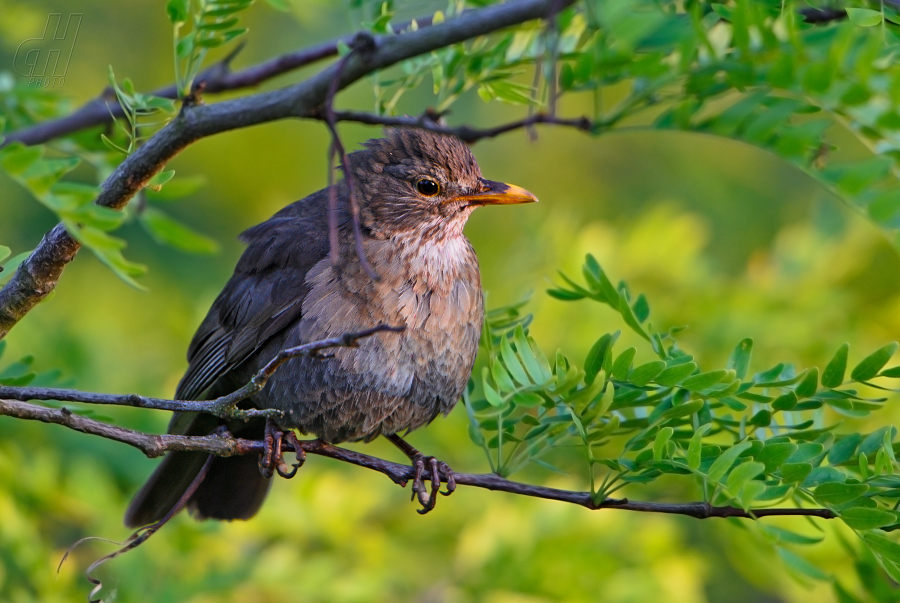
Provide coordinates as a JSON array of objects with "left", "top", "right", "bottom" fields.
[{"left": 348, "top": 128, "right": 537, "bottom": 238}]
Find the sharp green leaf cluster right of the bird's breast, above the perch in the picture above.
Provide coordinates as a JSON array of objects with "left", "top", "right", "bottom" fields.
[{"left": 464, "top": 256, "right": 900, "bottom": 577}]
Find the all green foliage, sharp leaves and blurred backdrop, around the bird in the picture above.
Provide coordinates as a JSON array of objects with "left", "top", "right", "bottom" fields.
[{"left": 0, "top": 0, "right": 900, "bottom": 601}]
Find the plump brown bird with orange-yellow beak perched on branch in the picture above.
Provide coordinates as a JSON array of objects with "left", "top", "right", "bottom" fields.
[{"left": 125, "top": 127, "right": 537, "bottom": 528}]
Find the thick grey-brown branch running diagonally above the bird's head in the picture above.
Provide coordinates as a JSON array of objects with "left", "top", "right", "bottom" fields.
[{"left": 0, "top": 0, "right": 574, "bottom": 339}]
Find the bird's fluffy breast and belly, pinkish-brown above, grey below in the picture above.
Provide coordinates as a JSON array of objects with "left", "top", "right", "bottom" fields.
[{"left": 278, "top": 236, "right": 484, "bottom": 442}]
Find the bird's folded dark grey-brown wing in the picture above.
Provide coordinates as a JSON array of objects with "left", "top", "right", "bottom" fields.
[{"left": 176, "top": 191, "right": 328, "bottom": 400}]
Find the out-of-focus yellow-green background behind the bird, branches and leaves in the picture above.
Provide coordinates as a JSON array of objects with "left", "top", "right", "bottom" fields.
[{"left": 0, "top": 0, "right": 900, "bottom": 603}]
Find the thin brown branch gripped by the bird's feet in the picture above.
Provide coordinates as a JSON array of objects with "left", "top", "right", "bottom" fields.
[{"left": 0, "top": 399, "right": 836, "bottom": 519}]
